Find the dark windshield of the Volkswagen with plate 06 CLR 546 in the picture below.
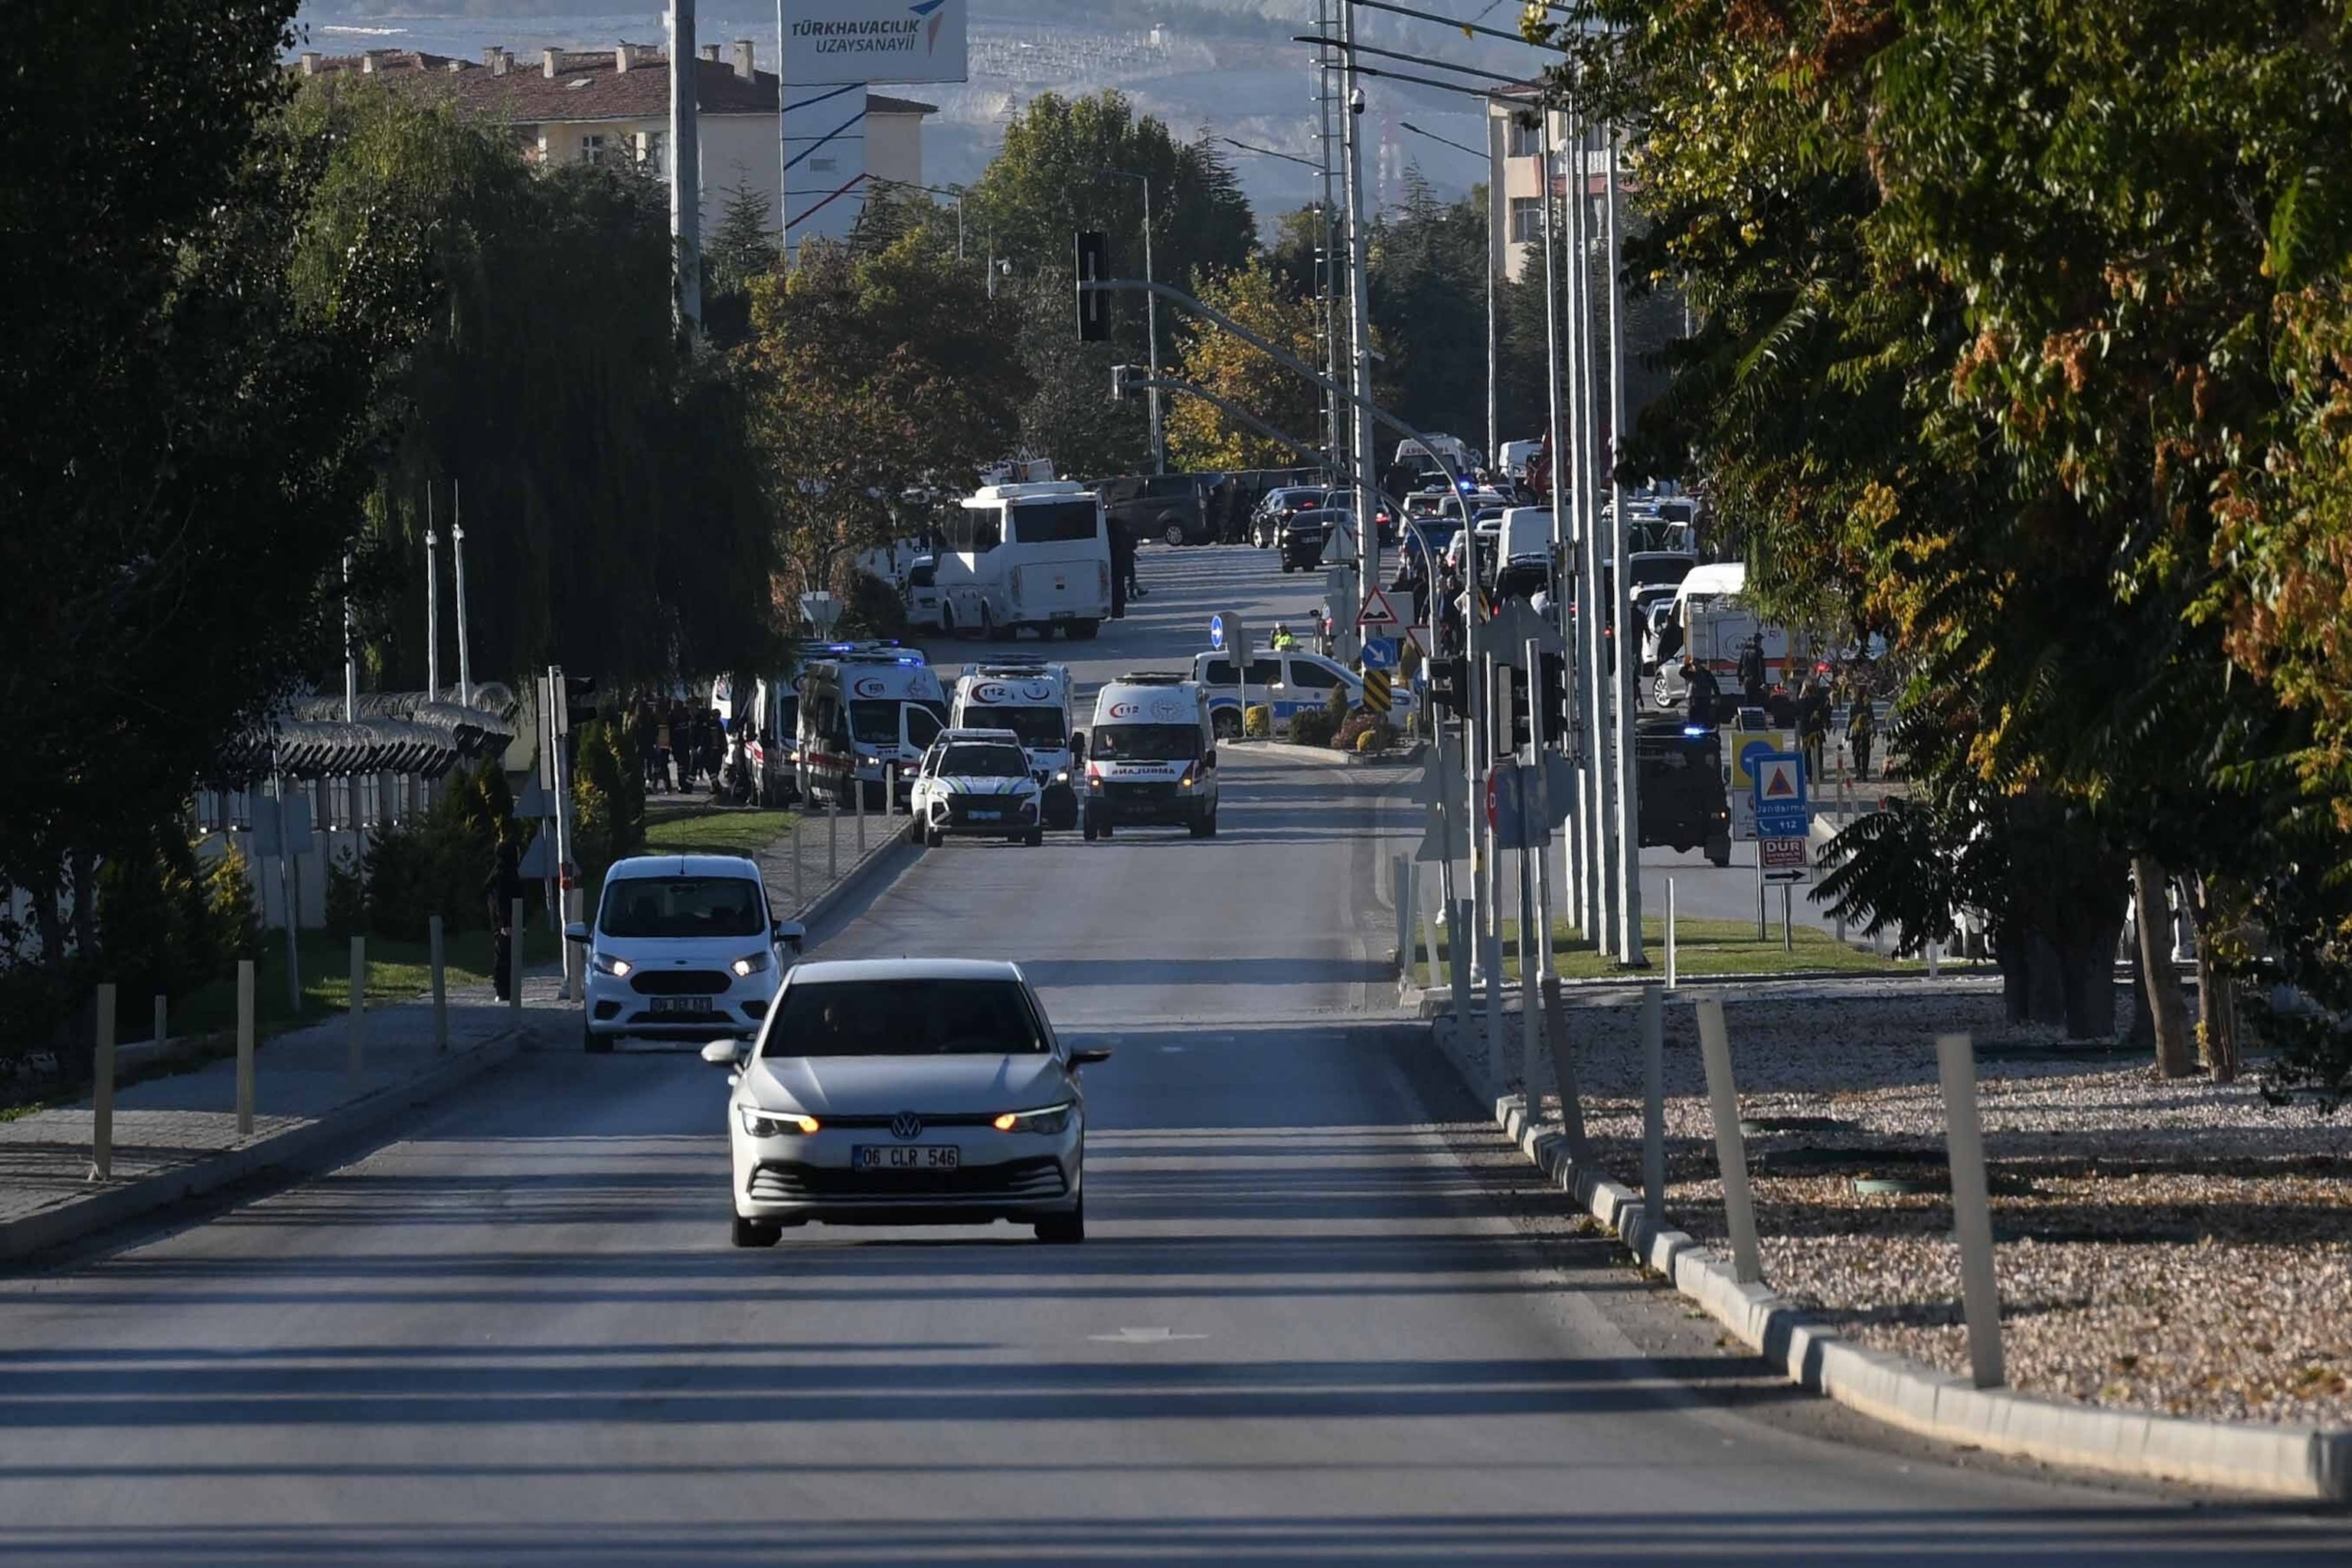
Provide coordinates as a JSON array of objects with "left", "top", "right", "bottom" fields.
[{"left": 760, "top": 978, "right": 1051, "bottom": 1056}]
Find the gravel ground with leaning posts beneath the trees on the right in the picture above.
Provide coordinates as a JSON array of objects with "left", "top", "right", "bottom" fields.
[{"left": 1472, "top": 985, "right": 2352, "bottom": 1425}]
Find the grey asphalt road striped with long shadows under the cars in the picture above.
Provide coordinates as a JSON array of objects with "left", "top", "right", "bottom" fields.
[{"left": 0, "top": 553, "right": 2352, "bottom": 1568}]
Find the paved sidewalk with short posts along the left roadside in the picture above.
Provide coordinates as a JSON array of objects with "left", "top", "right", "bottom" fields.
[{"left": 0, "top": 966, "right": 577, "bottom": 1258}]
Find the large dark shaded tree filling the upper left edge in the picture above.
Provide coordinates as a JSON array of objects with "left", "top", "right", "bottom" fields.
[{"left": 0, "top": 0, "right": 421, "bottom": 991}]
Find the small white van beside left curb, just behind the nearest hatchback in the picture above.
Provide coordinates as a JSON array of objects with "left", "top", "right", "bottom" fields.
[{"left": 564, "top": 856, "right": 805, "bottom": 1050}]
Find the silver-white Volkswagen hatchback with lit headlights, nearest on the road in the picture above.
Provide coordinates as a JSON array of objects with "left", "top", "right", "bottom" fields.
[{"left": 704, "top": 959, "right": 1110, "bottom": 1246}]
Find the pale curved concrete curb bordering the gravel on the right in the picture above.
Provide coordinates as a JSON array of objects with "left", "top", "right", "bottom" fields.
[{"left": 1477, "top": 1086, "right": 2352, "bottom": 1502}]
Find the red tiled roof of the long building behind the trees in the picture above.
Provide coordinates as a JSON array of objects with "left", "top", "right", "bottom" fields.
[{"left": 305, "top": 44, "right": 776, "bottom": 125}]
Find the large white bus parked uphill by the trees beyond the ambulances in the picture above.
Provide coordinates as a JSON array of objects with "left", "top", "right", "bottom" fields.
[{"left": 934, "top": 479, "right": 1110, "bottom": 642}]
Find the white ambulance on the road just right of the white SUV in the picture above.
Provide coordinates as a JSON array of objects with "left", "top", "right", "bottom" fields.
[{"left": 1084, "top": 672, "right": 1216, "bottom": 841}]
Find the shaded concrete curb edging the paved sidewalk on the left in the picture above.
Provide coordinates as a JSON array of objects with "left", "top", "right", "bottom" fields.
[{"left": 0, "top": 1008, "right": 571, "bottom": 1260}]
